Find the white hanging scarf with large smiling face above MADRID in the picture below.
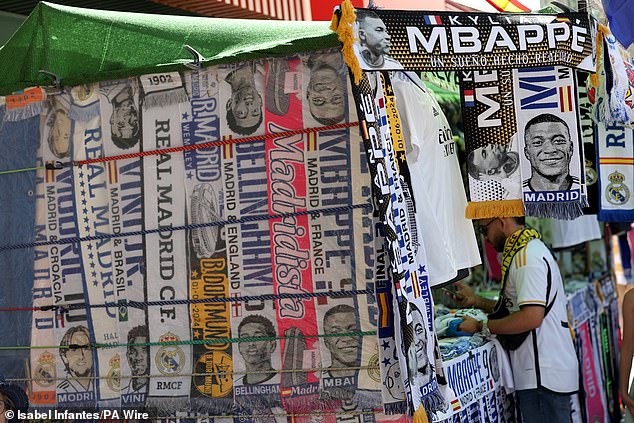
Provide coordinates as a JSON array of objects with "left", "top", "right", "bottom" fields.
[{"left": 513, "top": 66, "right": 587, "bottom": 219}]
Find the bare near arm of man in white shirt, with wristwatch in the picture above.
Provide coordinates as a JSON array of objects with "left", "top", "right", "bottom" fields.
[{"left": 458, "top": 305, "right": 546, "bottom": 335}]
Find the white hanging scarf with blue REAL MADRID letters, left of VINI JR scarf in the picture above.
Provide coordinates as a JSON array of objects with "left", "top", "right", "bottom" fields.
[{"left": 67, "top": 84, "right": 121, "bottom": 407}]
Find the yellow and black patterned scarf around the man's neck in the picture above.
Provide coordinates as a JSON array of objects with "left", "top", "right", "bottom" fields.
[{"left": 489, "top": 228, "right": 541, "bottom": 350}]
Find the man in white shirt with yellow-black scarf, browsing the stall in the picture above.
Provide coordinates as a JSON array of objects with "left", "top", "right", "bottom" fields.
[{"left": 452, "top": 217, "right": 579, "bottom": 423}]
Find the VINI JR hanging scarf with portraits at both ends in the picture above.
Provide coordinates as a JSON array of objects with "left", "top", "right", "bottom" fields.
[{"left": 99, "top": 78, "right": 150, "bottom": 407}]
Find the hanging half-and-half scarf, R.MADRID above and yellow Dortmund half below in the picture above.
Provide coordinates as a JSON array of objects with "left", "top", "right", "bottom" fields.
[{"left": 182, "top": 67, "right": 233, "bottom": 412}]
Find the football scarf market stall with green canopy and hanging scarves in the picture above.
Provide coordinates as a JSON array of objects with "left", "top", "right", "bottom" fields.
[{"left": 0, "top": 3, "right": 634, "bottom": 422}]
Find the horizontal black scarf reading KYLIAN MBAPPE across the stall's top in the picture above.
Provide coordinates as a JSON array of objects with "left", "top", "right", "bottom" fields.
[{"left": 354, "top": 9, "right": 596, "bottom": 71}]
